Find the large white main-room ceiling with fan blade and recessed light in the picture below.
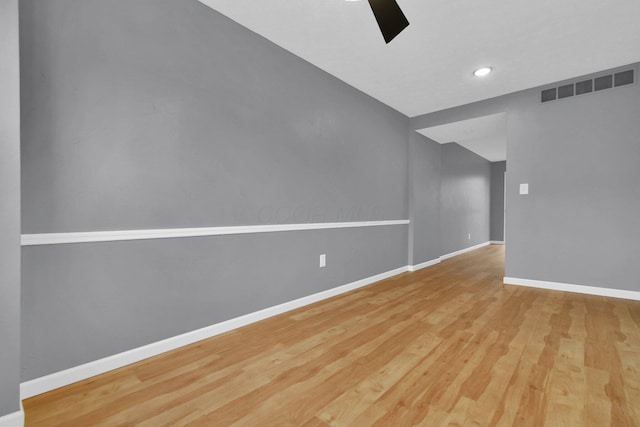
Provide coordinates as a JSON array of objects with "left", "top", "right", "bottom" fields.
[{"left": 200, "top": 0, "right": 640, "bottom": 117}]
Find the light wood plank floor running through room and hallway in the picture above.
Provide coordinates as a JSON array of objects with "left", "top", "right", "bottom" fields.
[{"left": 24, "top": 246, "right": 640, "bottom": 427}]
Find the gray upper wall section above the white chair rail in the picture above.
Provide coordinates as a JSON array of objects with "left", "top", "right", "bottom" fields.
[{"left": 21, "top": 0, "right": 408, "bottom": 233}]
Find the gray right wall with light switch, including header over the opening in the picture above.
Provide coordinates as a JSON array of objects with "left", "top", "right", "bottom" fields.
[{"left": 411, "top": 64, "right": 640, "bottom": 291}]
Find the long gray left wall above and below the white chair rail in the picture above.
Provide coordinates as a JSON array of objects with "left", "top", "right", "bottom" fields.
[{"left": 21, "top": 0, "right": 409, "bottom": 380}]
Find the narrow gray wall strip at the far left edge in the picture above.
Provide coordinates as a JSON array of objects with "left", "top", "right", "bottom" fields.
[{"left": 0, "top": 0, "right": 20, "bottom": 417}]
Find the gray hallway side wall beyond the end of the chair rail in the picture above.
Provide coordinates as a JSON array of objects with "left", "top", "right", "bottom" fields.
[{"left": 409, "top": 132, "right": 491, "bottom": 265}]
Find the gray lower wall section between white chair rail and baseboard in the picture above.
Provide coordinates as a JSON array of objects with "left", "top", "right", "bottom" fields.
[{"left": 22, "top": 226, "right": 407, "bottom": 381}]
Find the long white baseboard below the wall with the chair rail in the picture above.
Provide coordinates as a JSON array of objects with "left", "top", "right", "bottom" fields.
[{"left": 22, "top": 266, "right": 409, "bottom": 400}]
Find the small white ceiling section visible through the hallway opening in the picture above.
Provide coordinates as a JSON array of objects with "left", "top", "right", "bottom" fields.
[{"left": 417, "top": 113, "right": 507, "bottom": 162}]
